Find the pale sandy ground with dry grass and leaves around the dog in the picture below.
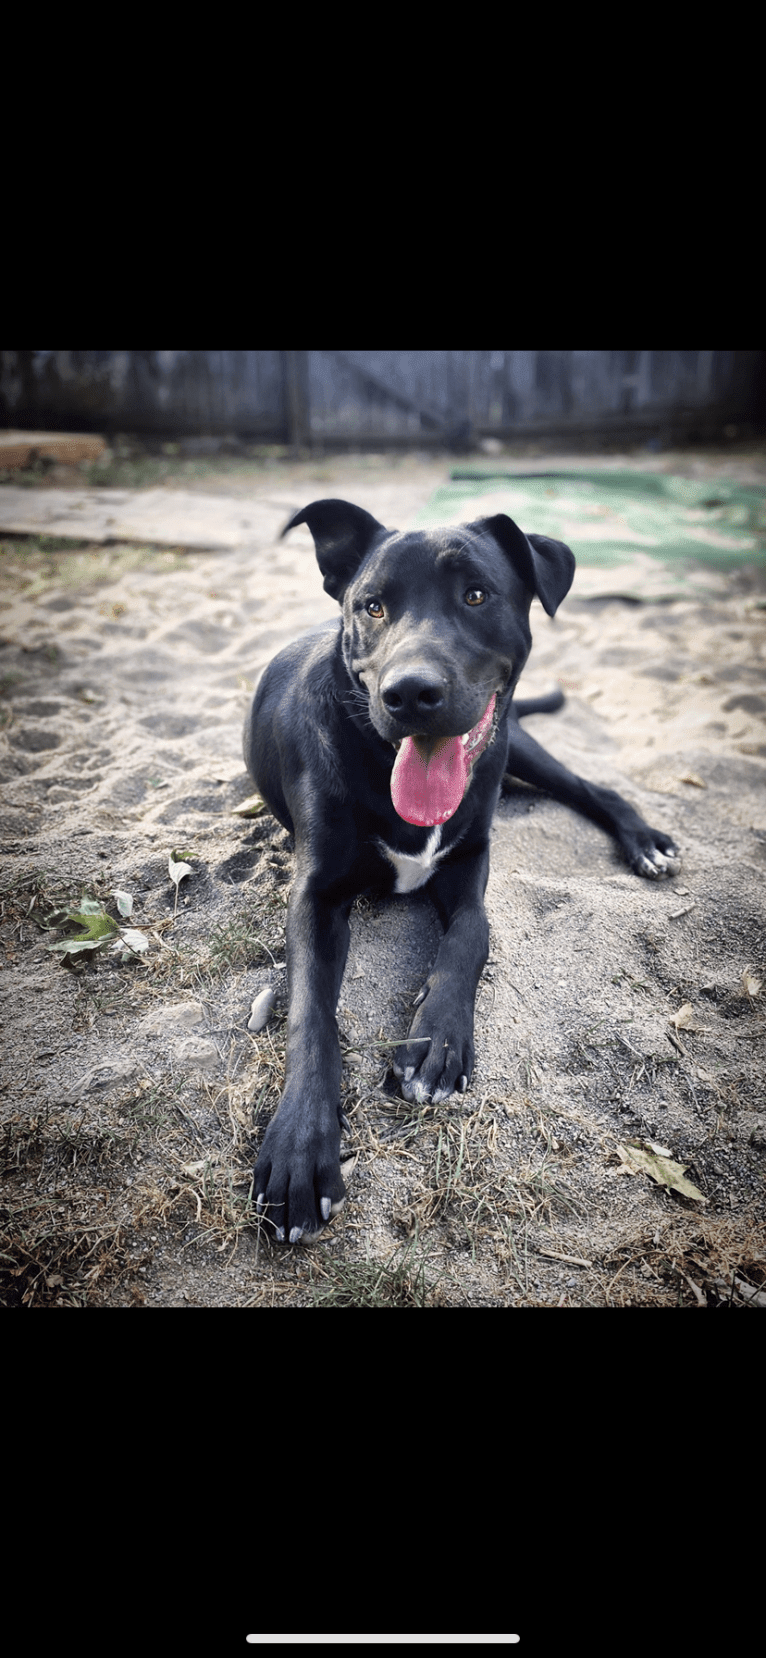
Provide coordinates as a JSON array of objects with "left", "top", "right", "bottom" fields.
[{"left": 0, "top": 451, "right": 766, "bottom": 1307}]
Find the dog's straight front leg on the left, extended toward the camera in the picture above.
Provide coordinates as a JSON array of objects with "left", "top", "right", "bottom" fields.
[{"left": 254, "top": 877, "right": 351, "bottom": 1244}]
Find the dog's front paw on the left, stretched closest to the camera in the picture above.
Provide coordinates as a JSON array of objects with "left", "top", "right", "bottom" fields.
[{"left": 252, "top": 1094, "right": 347, "bottom": 1244}]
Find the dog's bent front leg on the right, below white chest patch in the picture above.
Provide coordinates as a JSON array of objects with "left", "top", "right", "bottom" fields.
[{"left": 393, "top": 847, "right": 489, "bottom": 1103}]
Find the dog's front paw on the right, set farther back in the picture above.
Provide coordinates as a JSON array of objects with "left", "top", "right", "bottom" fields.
[{"left": 393, "top": 982, "right": 474, "bottom": 1106}]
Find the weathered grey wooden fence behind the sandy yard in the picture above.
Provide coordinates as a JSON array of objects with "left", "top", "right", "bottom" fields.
[{"left": 0, "top": 351, "right": 766, "bottom": 448}]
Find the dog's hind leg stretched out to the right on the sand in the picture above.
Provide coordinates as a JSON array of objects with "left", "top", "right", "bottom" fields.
[{"left": 506, "top": 721, "right": 681, "bottom": 879}]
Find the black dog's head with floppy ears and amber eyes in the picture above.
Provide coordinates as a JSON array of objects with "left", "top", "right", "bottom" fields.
[{"left": 282, "top": 501, "right": 574, "bottom": 822}]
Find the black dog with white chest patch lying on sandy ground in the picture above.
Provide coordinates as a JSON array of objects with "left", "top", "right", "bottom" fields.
[{"left": 245, "top": 501, "right": 678, "bottom": 1244}]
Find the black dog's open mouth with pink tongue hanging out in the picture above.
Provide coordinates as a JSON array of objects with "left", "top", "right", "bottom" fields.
[{"left": 391, "top": 693, "right": 497, "bottom": 829}]
